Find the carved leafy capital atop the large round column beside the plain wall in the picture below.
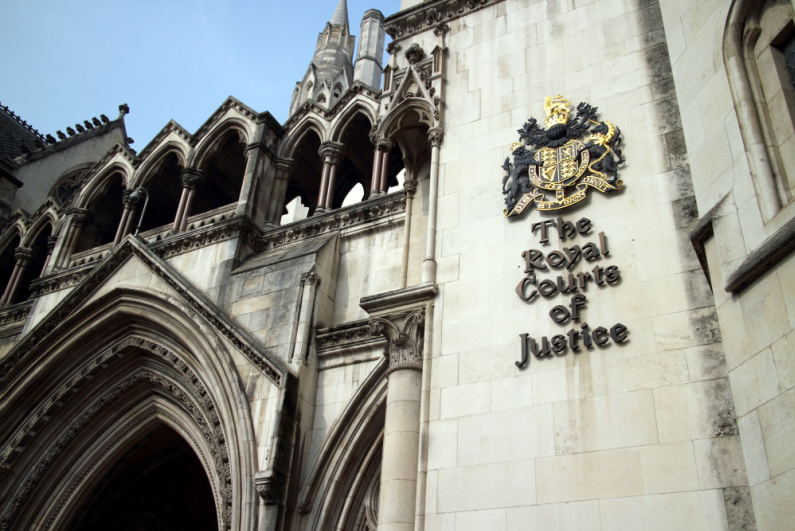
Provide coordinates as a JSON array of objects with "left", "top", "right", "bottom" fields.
[{"left": 370, "top": 308, "right": 425, "bottom": 374}]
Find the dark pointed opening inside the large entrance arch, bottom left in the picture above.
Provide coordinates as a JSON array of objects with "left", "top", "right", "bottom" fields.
[{"left": 72, "top": 425, "right": 218, "bottom": 531}]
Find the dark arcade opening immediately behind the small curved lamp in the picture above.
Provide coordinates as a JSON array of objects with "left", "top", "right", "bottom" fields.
[{"left": 140, "top": 153, "right": 182, "bottom": 232}]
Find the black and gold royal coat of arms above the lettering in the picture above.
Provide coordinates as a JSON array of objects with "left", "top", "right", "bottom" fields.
[{"left": 502, "top": 96, "right": 624, "bottom": 217}]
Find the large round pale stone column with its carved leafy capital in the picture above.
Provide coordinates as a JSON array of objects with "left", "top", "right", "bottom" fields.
[{"left": 370, "top": 309, "right": 425, "bottom": 531}]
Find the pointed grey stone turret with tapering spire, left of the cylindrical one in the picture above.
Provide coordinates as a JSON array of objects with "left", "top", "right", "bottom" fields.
[{"left": 290, "top": 0, "right": 356, "bottom": 115}]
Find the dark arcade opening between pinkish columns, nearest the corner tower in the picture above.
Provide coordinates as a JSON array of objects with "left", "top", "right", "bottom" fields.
[{"left": 331, "top": 113, "right": 373, "bottom": 208}]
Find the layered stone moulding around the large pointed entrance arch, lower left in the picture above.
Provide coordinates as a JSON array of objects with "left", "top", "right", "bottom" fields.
[{"left": 0, "top": 282, "right": 270, "bottom": 529}]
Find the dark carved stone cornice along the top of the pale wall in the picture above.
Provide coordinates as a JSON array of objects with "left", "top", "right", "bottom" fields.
[{"left": 384, "top": 0, "right": 502, "bottom": 42}]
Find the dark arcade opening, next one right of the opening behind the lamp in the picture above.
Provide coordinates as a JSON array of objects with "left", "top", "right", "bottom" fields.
[{"left": 191, "top": 131, "right": 246, "bottom": 215}]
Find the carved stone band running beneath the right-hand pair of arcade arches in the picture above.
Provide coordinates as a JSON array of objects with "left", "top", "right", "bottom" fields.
[{"left": 262, "top": 191, "right": 406, "bottom": 249}]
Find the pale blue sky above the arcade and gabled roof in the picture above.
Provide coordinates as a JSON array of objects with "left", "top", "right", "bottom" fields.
[{"left": 0, "top": 0, "right": 400, "bottom": 151}]
